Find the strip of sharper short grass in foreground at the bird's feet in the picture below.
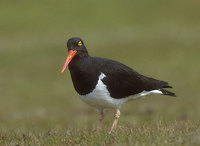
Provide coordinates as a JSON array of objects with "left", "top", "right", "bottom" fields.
[{"left": 0, "top": 119, "right": 200, "bottom": 145}]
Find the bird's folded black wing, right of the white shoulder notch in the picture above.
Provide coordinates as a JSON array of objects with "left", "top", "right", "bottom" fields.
[{"left": 93, "top": 58, "right": 175, "bottom": 99}]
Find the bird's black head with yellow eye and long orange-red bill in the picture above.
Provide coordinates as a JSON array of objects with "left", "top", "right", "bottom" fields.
[{"left": 61, "top": 37, "right": 88, "bottom": 73}]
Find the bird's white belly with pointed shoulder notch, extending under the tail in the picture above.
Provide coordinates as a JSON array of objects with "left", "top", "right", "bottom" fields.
[{"left": 79, "top": 73, "right": 162, "bottom": 109}]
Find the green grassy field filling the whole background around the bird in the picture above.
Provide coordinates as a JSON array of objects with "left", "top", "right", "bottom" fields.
[{"left": 0, "top": 0, "right": 200, "bottom": 145}]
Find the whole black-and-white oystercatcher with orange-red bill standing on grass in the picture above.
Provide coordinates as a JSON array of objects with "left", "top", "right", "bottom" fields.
[{"left": 61, "top": 37, "right": 176, "bottom": 133}]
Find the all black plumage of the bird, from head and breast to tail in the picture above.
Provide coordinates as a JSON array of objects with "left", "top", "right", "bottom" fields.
[{"left": 67, "top": 38, "right": 175, "bottom": 99}]
